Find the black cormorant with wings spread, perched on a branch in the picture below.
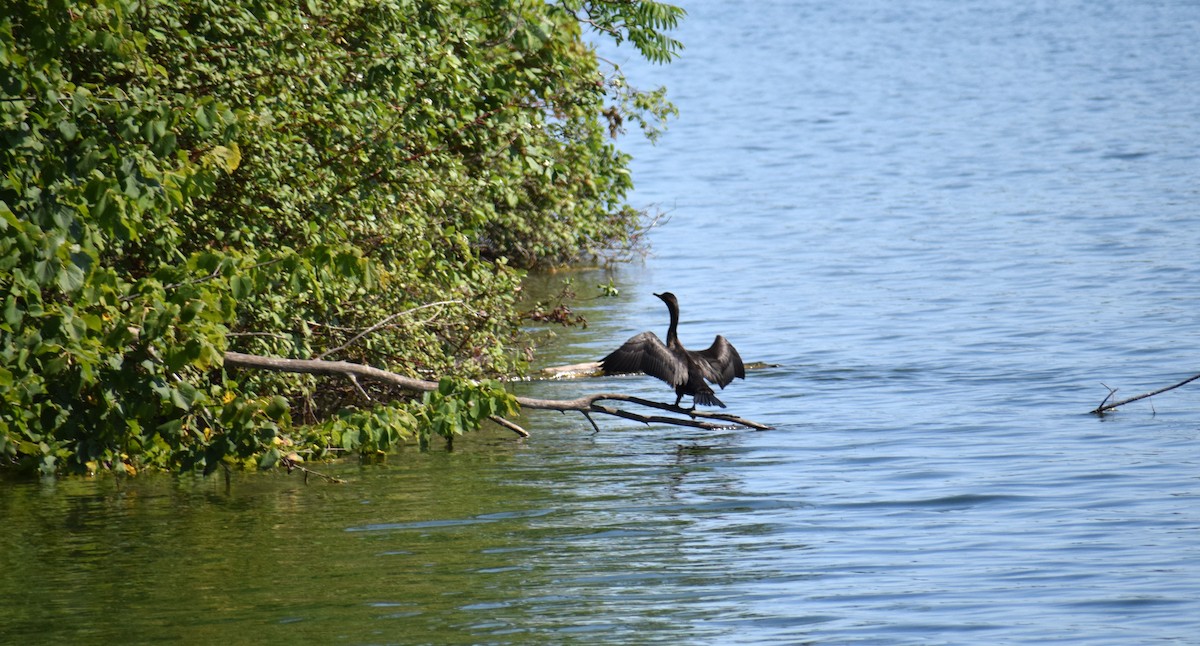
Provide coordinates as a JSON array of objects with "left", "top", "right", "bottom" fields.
[{"left": 600, "top": 292, "right": 746, "bottom": 408}]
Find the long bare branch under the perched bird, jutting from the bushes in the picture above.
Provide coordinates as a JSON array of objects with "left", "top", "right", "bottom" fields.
[{"left": 224, "top": 352, "right": 770, "bottom": 437}]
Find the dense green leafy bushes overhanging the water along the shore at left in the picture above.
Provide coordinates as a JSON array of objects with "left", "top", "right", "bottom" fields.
[{"left": 0, "top": 0, "right": 684, "bottom": 475}]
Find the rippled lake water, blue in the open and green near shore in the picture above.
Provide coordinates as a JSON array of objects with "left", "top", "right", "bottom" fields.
[{"left": 0, "top": 0, "right": 1200, "bottom": 645}]
